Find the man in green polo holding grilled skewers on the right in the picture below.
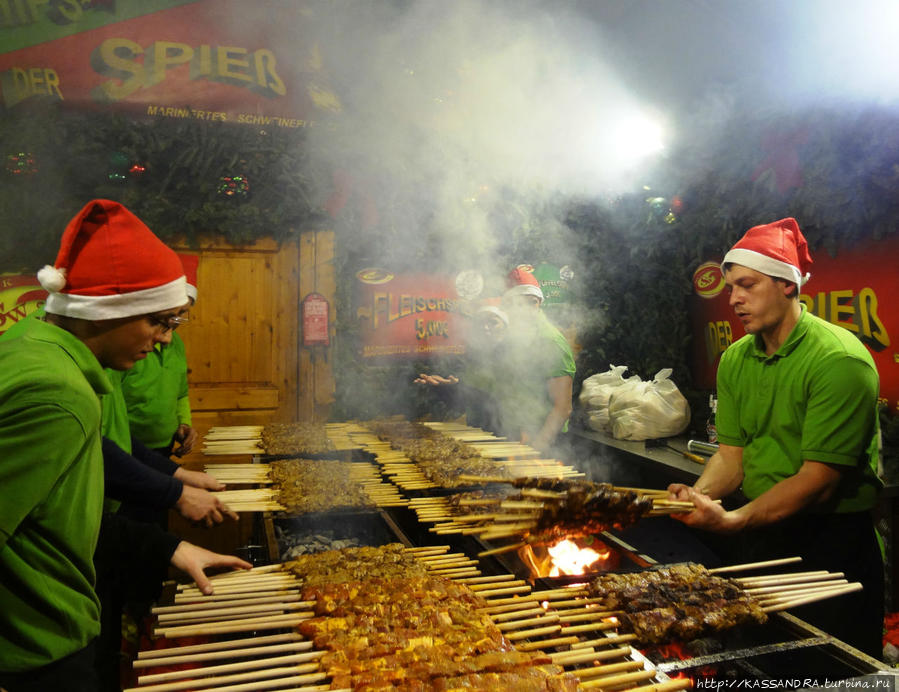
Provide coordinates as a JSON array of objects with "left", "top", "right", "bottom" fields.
[{"left": 669, "top": 218, "right": 884, "bottom": 657}]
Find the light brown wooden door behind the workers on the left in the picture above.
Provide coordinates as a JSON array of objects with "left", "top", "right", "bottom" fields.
[{"left": 172, "top": 232, "right": 334, "bottom": 553}]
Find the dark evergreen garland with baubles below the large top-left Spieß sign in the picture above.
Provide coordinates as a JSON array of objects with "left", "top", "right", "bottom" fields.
[{"left": 0, "top": 102, "right": 323, "bottom": 271}]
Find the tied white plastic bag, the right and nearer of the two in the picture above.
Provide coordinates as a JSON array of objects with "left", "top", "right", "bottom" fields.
[{"left": 609, "top": 368, "right": 690, "bottom": 440}]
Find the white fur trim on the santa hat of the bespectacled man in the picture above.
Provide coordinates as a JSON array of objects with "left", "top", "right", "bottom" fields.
[{"left": 44, "top": 276, "right": 187, "bottom": 320}]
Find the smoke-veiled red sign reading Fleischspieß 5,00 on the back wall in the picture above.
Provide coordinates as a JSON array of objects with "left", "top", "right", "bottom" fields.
[{"left": 356, "top": 268, "right": 467, "bottom": 358}]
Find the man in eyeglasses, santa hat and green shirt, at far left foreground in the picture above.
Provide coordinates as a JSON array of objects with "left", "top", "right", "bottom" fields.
[{"left": 0, "top": 200, "right": 250, "bottom": 692}]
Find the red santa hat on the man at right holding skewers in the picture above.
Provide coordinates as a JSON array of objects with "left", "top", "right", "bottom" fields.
[{"left": 721, "top": 218, "right": 812, "bottom": 286}]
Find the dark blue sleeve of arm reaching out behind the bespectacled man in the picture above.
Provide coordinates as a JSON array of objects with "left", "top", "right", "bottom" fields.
[{"left": 103, "top": 437, "right": 184, "bottom": 509}]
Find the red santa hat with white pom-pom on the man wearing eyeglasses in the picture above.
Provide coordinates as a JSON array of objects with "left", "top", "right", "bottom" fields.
[{"left": 37, "top": 199, "right": 187, "bottom": 320}]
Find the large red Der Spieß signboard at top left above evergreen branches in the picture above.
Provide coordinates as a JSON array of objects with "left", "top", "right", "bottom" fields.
[{"left": 0, "top": 0, "right": 340, "bottom": 128}]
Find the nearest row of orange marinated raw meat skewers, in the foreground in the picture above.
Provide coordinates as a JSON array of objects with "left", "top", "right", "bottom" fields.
[{"left": 135, "top": 546, "right": 660, "bottom": 692}]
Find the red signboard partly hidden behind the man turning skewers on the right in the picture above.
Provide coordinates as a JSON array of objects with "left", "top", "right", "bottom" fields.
[{"left": 691, "top": 237, "right": 899, "bottom": 413}]
